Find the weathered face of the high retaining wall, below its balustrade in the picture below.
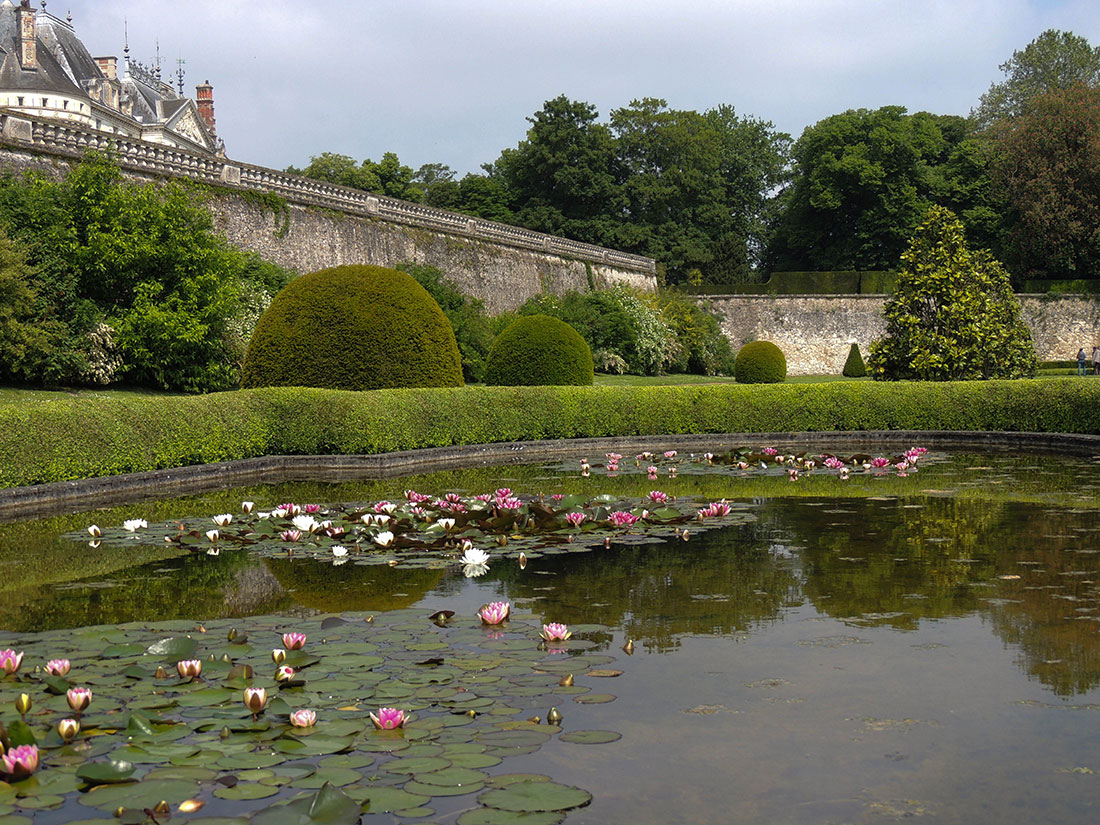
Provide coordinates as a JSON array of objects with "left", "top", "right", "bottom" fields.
[{"left": 206, "top": 195, "right": 656, "bottom": 314}]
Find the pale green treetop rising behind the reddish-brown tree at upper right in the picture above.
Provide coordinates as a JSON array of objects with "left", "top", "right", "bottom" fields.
[{"left": 970, "top": 29, "right": 1100, "bottom": 130}]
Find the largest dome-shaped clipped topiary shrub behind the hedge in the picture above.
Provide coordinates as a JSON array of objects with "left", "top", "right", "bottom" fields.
[{"left": 241, "top": 266, "right": 462, "bottom": 389}]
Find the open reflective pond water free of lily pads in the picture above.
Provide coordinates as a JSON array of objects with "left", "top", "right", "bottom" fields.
[{"left": 0, "top": 457, "right": 1100, "bottom": 825}]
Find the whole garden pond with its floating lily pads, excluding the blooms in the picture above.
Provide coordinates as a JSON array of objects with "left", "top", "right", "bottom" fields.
[{"left": 0, "top": 453, "right": 1100, "bottom": 825}]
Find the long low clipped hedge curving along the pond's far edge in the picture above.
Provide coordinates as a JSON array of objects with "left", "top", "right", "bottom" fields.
[{"left": 0, "top": 377, "right": 1100, "bottom": 487}]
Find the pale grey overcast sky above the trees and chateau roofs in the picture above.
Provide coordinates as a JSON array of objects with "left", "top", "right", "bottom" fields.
[{"left": 66, "top": 0, "right": 1100, "bottom": 175}]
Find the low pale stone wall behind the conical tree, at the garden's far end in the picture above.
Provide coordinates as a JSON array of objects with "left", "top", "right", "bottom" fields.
[{"left": 706, "top": 295, "right": 1100, "bottom": 375}]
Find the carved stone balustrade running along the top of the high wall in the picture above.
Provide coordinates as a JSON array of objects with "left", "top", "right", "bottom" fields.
[{"left": 0, "top": 110, "right": 657, "bottom": 275}]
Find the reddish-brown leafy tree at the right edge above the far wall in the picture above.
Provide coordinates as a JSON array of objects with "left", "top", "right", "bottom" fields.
[{"left": 989, "top": 85, "right": 1100, "bottom": 278}]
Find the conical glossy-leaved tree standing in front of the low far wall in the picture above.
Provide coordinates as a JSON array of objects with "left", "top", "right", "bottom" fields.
[{"left": 868, "top": 207, "right": 1036, "bottom": 381}]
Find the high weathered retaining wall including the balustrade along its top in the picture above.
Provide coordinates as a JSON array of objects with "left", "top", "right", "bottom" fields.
[{"left": 0, "top": 111, "right": 657, "bottom": 312}]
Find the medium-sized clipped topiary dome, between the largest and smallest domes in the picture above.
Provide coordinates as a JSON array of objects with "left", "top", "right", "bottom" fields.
[{"left": 485, "top": 315, "right": 593, "bottom": 386}]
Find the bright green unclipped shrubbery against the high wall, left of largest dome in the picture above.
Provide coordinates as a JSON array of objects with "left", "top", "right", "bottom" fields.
[{"left": 0, "top": 153, "right": 289, "bottom": 392}]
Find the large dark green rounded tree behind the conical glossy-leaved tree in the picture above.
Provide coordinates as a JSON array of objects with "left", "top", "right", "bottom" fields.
[{"left": 765, "top": 106, "right": 998, "bottom": 271}]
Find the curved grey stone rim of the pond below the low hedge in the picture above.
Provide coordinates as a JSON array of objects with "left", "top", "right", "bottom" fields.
[{"left": 0, "top": 430, "right": 1100, "bottom": 521}]
